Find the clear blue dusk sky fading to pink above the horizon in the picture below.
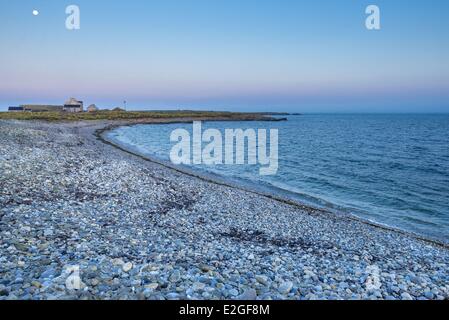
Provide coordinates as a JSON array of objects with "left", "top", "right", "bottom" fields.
[{"left": 0, "top": 0, "right": 449, "bottom": 113}]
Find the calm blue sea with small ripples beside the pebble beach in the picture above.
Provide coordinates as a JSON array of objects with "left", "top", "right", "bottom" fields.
[{"left": 108, "top": 114, "right": 449, "bottom": 242}]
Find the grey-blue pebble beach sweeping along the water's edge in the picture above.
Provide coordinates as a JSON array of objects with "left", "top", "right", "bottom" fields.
[{"left": 0, "top": 120, "right": 449, "bottom": 300}]
